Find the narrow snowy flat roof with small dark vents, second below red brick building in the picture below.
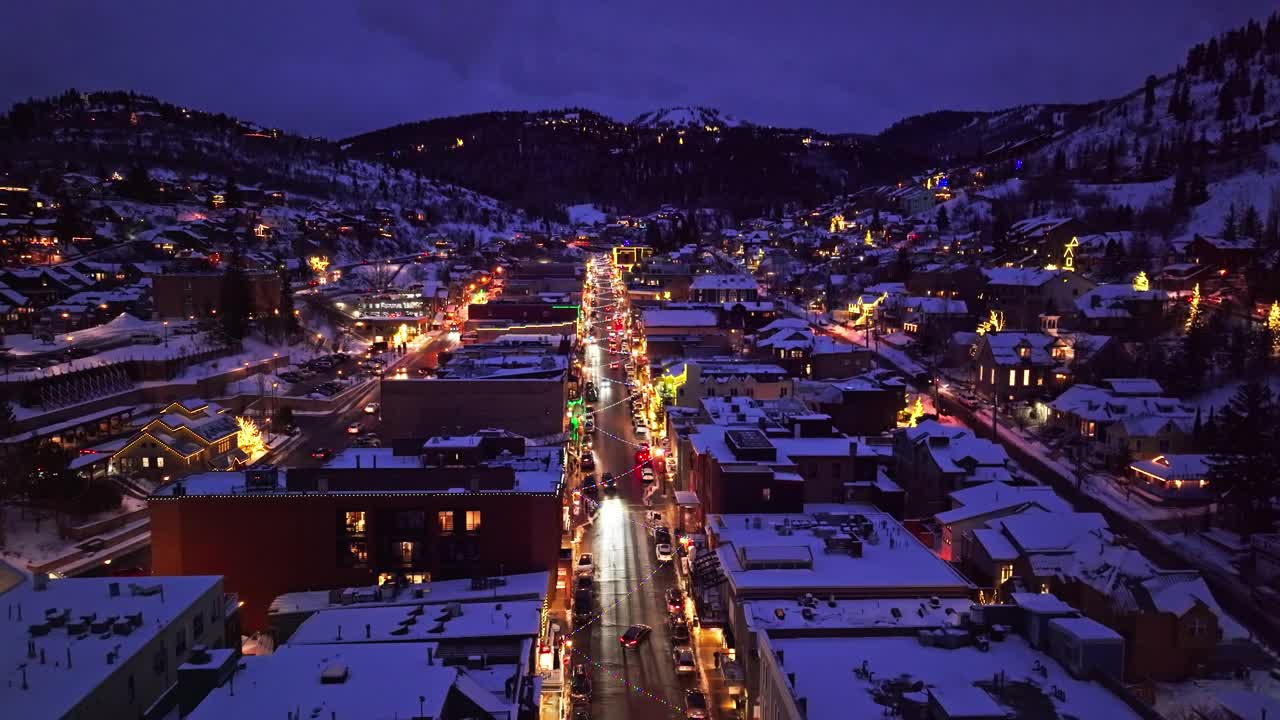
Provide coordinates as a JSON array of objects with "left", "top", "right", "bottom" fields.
[{"left": 289, "top": 600, "right": 543, "bottom": 644}]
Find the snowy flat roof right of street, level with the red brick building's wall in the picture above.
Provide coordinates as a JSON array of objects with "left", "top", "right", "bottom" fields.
[{"left": 708, "top": 505, "right": 973, "bottom": 598}]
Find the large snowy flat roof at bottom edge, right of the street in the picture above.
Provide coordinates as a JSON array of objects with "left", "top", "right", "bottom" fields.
[{"left": 769, "top": 635, "right": 1138, "bottom": 720}]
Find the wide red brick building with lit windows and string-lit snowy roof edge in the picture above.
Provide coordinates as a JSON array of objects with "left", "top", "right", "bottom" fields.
[{"left": 150, "top": 433, "right": 563, "bottom": 632}]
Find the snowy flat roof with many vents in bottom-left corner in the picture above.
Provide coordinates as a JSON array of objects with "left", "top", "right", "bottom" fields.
[{"left": 0, "top": 575, "right": 223, "bottom": 719}]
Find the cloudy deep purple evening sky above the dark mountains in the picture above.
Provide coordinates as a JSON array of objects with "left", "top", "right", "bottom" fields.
[{"left": 0, "top": 0, "right": 1275, "bottom": 137}]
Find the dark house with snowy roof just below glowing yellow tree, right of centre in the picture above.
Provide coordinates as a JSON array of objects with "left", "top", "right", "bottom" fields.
[{"left": 893, "top": 420, "right": 1014, "bottom": 516}]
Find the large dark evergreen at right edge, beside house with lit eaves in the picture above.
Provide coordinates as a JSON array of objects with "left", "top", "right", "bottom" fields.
[{"left": 1206, "top": 380, "right": 1280, "bottom": 536}]
